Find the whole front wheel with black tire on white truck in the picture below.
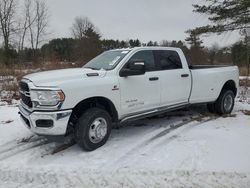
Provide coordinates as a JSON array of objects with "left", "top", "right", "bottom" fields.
[{"left": 75, "top": 108, "right": 112, "bottom": 151}]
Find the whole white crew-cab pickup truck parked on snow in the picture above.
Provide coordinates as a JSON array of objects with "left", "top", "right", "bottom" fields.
[{"left": 19, "top": 47, "right": 239, "bottom": 151}]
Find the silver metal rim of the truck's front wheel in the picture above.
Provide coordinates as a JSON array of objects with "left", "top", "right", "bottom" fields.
[{"left": 89, "top": 118, "right": 107, "bottom": 143}]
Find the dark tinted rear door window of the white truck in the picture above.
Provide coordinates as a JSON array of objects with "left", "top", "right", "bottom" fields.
[{"left": 154, "top": 50, "right": 182, "bottom": 70}]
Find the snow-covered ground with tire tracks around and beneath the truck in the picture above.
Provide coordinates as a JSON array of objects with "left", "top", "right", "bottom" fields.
[{"left": 0, "top": 94, "right": 250, "bottom": 188}]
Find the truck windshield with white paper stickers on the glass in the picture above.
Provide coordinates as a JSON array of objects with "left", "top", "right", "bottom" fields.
[{"left": 83, "top": 50, "right": 129, "bottom": 70}]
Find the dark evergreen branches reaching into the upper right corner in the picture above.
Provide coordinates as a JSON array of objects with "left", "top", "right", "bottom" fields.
[{"left": 193, "top": 0, "right": 250, "bottom": 34}]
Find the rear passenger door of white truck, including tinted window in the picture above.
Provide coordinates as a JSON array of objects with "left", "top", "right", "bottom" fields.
[{"left": 154, "top": 50, "right": 191, "bottom": 107}]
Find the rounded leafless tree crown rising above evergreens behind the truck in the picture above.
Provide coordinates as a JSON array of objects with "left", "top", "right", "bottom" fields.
[{"left": 71, "top": 16, "right": 95, "bottom": 39}]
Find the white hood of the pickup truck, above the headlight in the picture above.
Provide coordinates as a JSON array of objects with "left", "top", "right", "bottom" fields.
[{"left": 24, "top": 68, "right": 107, "bottom": 87}]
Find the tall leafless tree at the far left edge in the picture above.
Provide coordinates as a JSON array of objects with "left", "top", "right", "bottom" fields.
[{"left": 0, "top": 0, "right": 16, "bottom": 52}]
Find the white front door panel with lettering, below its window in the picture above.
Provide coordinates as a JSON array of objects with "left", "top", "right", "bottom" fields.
[{"left": 119, "top": 72, "right": 161, "bottom": 116}]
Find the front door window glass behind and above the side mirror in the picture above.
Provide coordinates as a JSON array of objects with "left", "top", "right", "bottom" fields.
[{"left": 129, "top": 50, "right": 155, "bottom": 71}]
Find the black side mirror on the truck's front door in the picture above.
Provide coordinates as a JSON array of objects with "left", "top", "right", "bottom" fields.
[{"left": 120, "top": 60, "right": 145, "bottom": 77}]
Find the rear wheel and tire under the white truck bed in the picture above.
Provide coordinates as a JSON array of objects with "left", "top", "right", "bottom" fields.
[{"left": 215, "top": 90, "right": 235, "bottom": 115}]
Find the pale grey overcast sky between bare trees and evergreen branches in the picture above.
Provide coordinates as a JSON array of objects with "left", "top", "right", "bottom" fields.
[{"left": 47, "top": 0, "right": 239, "bottom": 46}]
